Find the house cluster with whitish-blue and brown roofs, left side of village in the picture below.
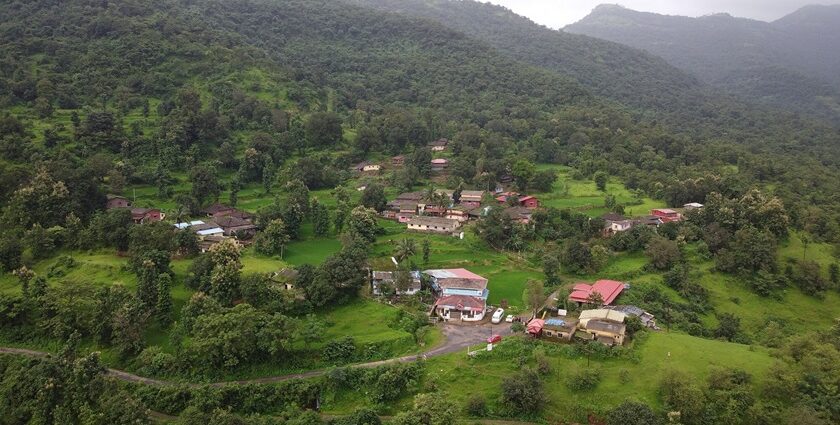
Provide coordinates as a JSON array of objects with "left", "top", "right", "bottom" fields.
[{"left": 174, "top": 204, "right": 257, "bottom": 252}]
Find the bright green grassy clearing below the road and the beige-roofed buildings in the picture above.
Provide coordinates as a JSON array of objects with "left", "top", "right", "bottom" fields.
[{"left": 324, "top": 332, "right": 774, "bottom": 423}]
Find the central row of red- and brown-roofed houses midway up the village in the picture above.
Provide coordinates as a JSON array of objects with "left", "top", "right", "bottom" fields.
[{"left": 382, "top": 190, "right": 540, "bottom": 234}]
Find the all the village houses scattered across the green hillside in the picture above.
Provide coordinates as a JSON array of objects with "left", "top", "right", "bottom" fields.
[{"left": 100, "top": 134, "right": 703, "bottom": 349}]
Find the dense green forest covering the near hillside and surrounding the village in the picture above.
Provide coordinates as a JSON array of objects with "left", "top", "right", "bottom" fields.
[{"left": 0, "top": 0, "right": 840, "bottom": 424}]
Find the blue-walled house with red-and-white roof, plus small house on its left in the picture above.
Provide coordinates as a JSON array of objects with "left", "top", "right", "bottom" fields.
[{"left": 371, "top": 269, "right": 490, "bottom": 322}]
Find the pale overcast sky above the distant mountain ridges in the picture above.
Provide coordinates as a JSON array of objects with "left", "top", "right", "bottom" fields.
[{"left": 482, "top": 0, "right": 840, "bottom": 28}]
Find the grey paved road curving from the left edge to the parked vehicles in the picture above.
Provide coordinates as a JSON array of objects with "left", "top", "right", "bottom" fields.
[{"left": 0, "top": 324, "right": 511, "bottom": 387}]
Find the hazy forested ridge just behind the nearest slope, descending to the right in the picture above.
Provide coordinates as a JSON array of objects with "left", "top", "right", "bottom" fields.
[{"left": 346, "top": 0, "right": 834, "bottom": 158}]
